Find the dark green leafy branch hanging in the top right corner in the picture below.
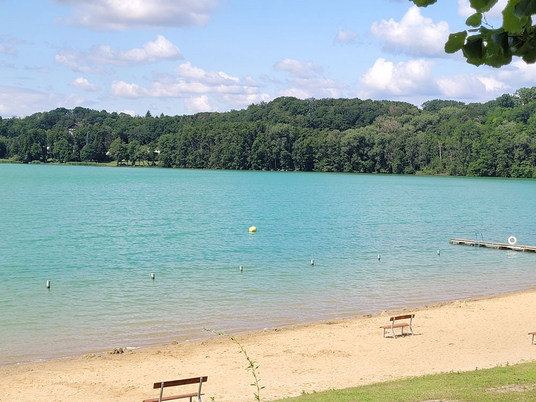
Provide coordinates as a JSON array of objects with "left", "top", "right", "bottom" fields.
[{"left": 410, "top": 0, "right": 536, "bottom": 67}]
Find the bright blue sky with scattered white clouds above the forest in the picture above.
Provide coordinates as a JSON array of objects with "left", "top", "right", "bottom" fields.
[{"left": 0, "top": 0, "right": 536, "bottom": 118}]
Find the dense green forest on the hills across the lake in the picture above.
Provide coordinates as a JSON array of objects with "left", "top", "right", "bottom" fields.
[{"left": 0, "top": 87, "right": 536, "bottom": 178}]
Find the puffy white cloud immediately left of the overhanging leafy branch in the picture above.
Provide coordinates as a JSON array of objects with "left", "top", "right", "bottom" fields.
[{"left": 370, "top": 6, "right": 450, "bottom": 57}]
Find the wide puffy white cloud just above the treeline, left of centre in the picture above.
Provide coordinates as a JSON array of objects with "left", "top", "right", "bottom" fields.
[{"left": 111, "top": 62, "right": 271, "bottom": 110}]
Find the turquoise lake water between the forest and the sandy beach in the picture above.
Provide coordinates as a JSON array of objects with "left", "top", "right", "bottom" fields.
[{"left": 0, "top": 165, "right": 536, "bottom": 365}]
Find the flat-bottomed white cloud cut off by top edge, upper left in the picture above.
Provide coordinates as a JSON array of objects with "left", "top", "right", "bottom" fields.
[{"left": 56, "top": 0, "right": 219, "bottom": 30}]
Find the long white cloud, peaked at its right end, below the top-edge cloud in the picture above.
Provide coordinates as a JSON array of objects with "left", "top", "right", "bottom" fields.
[{"left": 55, "top": 35, "right": 182, "bottom": 74}]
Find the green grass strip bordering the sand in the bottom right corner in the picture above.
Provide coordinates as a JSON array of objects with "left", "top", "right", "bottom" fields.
[{"left": 274, "top": 362, "right": 536, "bottom": 402}]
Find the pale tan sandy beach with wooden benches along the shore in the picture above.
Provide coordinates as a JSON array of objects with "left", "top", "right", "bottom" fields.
[{"left": 0, "top": 289, "right": 536, "bottom": 402}]
